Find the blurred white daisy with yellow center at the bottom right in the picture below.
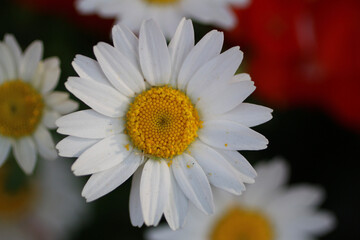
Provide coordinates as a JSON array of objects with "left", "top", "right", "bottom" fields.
[{"left": 147, "top": 160, "right": 335, "bottom": 240}]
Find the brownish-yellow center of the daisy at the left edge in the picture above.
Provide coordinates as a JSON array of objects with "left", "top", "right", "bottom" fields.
[{"left": 0, "top": 80, "right": 44, "bottom": 138}]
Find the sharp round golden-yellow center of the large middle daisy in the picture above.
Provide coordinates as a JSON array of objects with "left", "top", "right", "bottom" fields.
[{"left": 126, "top": 86, "right": 201, "bottom": 159}]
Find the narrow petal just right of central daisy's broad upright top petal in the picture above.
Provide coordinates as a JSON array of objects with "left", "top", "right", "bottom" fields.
[{"left": 169, "top": 18, "right": 195, "bottom": 87}]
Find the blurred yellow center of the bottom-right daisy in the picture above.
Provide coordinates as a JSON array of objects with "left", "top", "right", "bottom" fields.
[{"left": 210, "top": 207, "right": 274, "bottom": 240}]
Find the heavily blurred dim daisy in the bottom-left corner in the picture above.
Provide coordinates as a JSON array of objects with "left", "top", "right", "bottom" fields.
[{"left": 0, "top": 158, "right": 89, "bottom": 240}]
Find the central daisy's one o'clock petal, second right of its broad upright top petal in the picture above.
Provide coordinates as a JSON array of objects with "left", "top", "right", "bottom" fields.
[{"left": 178, "top": 30, "right": 224, "bottom": 90}]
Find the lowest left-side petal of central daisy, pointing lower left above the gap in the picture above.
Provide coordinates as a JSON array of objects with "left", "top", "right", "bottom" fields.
[{"left": 82, "top": 152, "right": 141, "bottom": 202}]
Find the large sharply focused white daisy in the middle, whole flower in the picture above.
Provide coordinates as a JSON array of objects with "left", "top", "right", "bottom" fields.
[{"left": 56, "top": 19, "right": 271, "bottom": 229}]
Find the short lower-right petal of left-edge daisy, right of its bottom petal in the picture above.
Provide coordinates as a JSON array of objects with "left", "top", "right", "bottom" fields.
[{"left": 34, "top": 124, "right": 58, "bottom": 160}]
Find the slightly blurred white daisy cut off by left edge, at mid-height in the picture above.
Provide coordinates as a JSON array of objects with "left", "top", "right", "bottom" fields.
[{"left": 0, "top": 35, "right": 78, "bottom": 174}]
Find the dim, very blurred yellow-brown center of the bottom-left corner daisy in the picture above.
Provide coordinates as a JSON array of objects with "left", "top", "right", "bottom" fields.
[{"left": 0, "top": 166, "right": 34, "bottom": 219}]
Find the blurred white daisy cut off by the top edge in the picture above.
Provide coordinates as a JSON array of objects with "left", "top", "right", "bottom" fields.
[{"left": 77, "top": 0, "right": 250, "bottom": 37}]
